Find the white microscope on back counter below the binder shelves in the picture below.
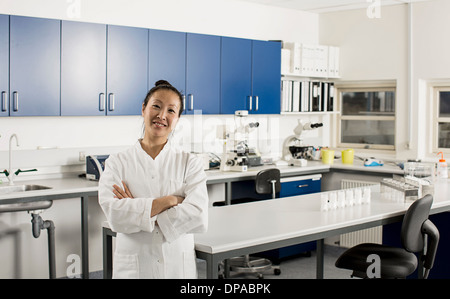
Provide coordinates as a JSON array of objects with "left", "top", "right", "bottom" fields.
[{"left": 283, "top": 119, "right": 323, "bottom": 166}]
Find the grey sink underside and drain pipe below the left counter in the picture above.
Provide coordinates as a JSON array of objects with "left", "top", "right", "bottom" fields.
[{"left": 0, "top": 200, "right": 56, "bottom": 279}]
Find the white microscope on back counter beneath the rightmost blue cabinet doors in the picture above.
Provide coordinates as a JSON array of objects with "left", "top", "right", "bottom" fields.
[{"left": 220, "top": 110, "right": 262, "bottom": 171}]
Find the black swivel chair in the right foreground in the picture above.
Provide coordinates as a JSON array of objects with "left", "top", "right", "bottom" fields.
[{"left": 336, "top": 194, "right": 439, "bottom": 279}]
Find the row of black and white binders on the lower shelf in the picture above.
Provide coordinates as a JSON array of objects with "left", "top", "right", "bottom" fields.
[{"left": 281, "top": 80, "right": 334, "bottom": 112}]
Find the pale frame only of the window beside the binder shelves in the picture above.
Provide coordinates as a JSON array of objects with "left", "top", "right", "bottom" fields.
[{"left": 335, "top": 83, "right": 398, "bottom": 152}]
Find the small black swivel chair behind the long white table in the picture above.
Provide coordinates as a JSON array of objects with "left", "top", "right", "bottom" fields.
[{"left": 228, "top": 168, "right": 281, "bottom": 278}]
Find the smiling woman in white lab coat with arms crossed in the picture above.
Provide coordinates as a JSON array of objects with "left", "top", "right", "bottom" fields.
[{"left": 99, "top": 80, "right": 208, "bottom": 278}]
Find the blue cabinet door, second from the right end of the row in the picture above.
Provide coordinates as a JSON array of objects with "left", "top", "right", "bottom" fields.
[{"left": 220, "top": 37, "right": 252, "bottom": 114}]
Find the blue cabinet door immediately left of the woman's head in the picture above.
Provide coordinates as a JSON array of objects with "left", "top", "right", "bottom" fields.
[{"left": 106, "top": 25, "right": 148, "bottom": 115}]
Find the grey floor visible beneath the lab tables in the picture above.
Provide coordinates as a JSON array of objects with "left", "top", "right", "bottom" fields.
[{"left": 90, "top": 245, "right": 351, "bottom": 279}]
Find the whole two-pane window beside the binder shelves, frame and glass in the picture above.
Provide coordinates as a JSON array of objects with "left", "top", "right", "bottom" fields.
[{"left": 337, "top": 87, "right": 395, "bottom": 150}]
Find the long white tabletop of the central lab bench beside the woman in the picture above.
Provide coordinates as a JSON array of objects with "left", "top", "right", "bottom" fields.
[{"left": 195, "top": 180, "right": 450, "bottom": 254}]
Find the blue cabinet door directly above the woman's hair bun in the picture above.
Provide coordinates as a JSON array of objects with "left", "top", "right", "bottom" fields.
[{"left": 148, "top": 29, "right": 186, "bottom": 94}]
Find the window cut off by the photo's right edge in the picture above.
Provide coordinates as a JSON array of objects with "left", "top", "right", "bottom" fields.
[{"left": 433, "top": 86, "right": 450, "bottom": 153}]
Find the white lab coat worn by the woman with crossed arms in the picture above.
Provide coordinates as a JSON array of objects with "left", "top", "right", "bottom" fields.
[{"left": 99, "top": 141, "right": 208, "bottom": 278}]
